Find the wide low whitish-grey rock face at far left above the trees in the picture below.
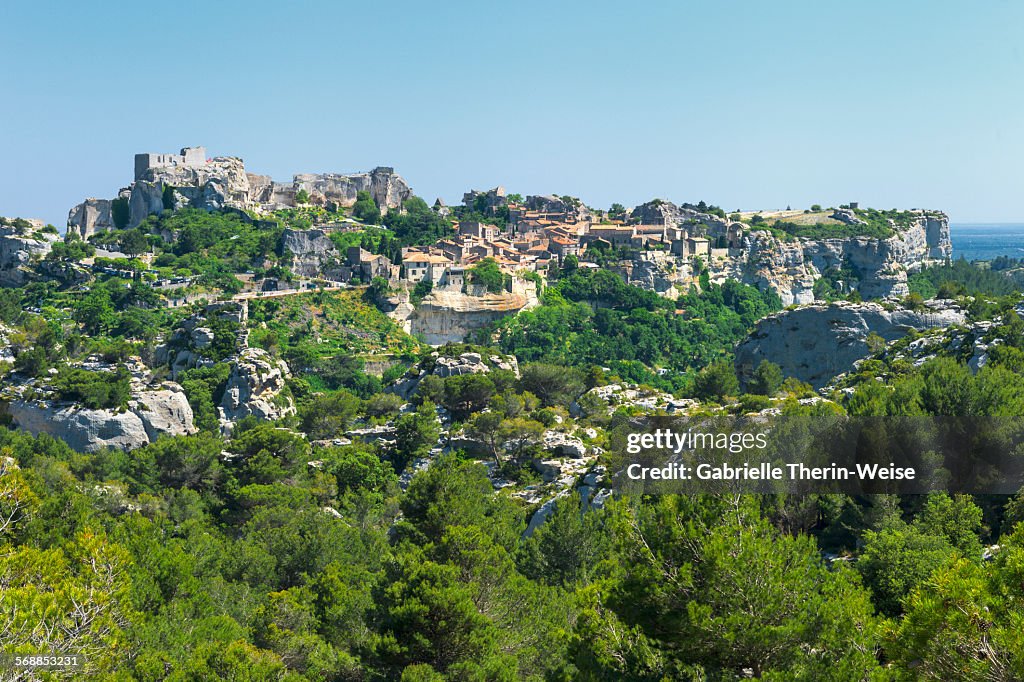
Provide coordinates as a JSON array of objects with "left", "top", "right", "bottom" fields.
[{"left": 8, "top": 385, "right": 198, "bottom": 453}]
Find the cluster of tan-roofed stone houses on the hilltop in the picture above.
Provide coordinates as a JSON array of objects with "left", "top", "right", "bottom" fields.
[{"left": 346, "top": 187, "right": 741, "bottom": 289}]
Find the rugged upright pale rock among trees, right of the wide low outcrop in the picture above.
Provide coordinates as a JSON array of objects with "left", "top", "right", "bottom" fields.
[{"left": 220, "top": 348, "right": 295, "bottom": 422}]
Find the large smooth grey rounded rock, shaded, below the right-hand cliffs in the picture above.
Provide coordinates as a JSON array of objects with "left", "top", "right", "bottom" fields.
[{"left": 735, "top": 302, "right": 965, "bottom": 388}]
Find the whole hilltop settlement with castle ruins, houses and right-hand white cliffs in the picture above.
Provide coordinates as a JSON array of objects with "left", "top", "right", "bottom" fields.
[{"left": 48, "top": 147, "right": 950, "bottom": 311}]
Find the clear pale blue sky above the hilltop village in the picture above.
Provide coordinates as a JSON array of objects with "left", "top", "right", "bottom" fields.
[{"left": 0, "top": 0, "right": 1024, "bottom": 226}]
